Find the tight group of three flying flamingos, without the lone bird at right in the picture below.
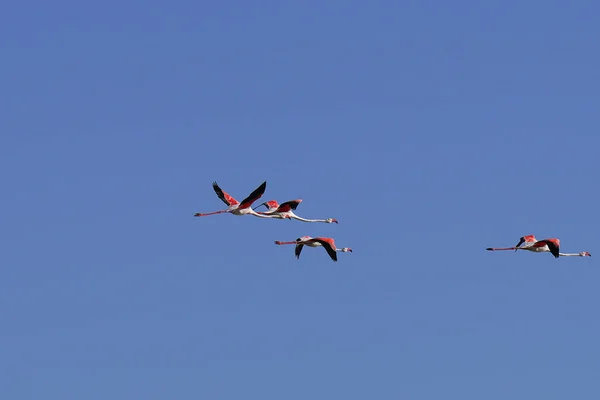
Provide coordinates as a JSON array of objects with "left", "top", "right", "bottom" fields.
[{"left": 194, "top": 181, "right": 352, "bottom": 261}]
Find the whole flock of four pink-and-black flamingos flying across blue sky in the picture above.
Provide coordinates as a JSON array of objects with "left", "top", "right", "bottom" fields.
[{"left": 194, "top": 181, "right": 592, "bottom": 261}]
